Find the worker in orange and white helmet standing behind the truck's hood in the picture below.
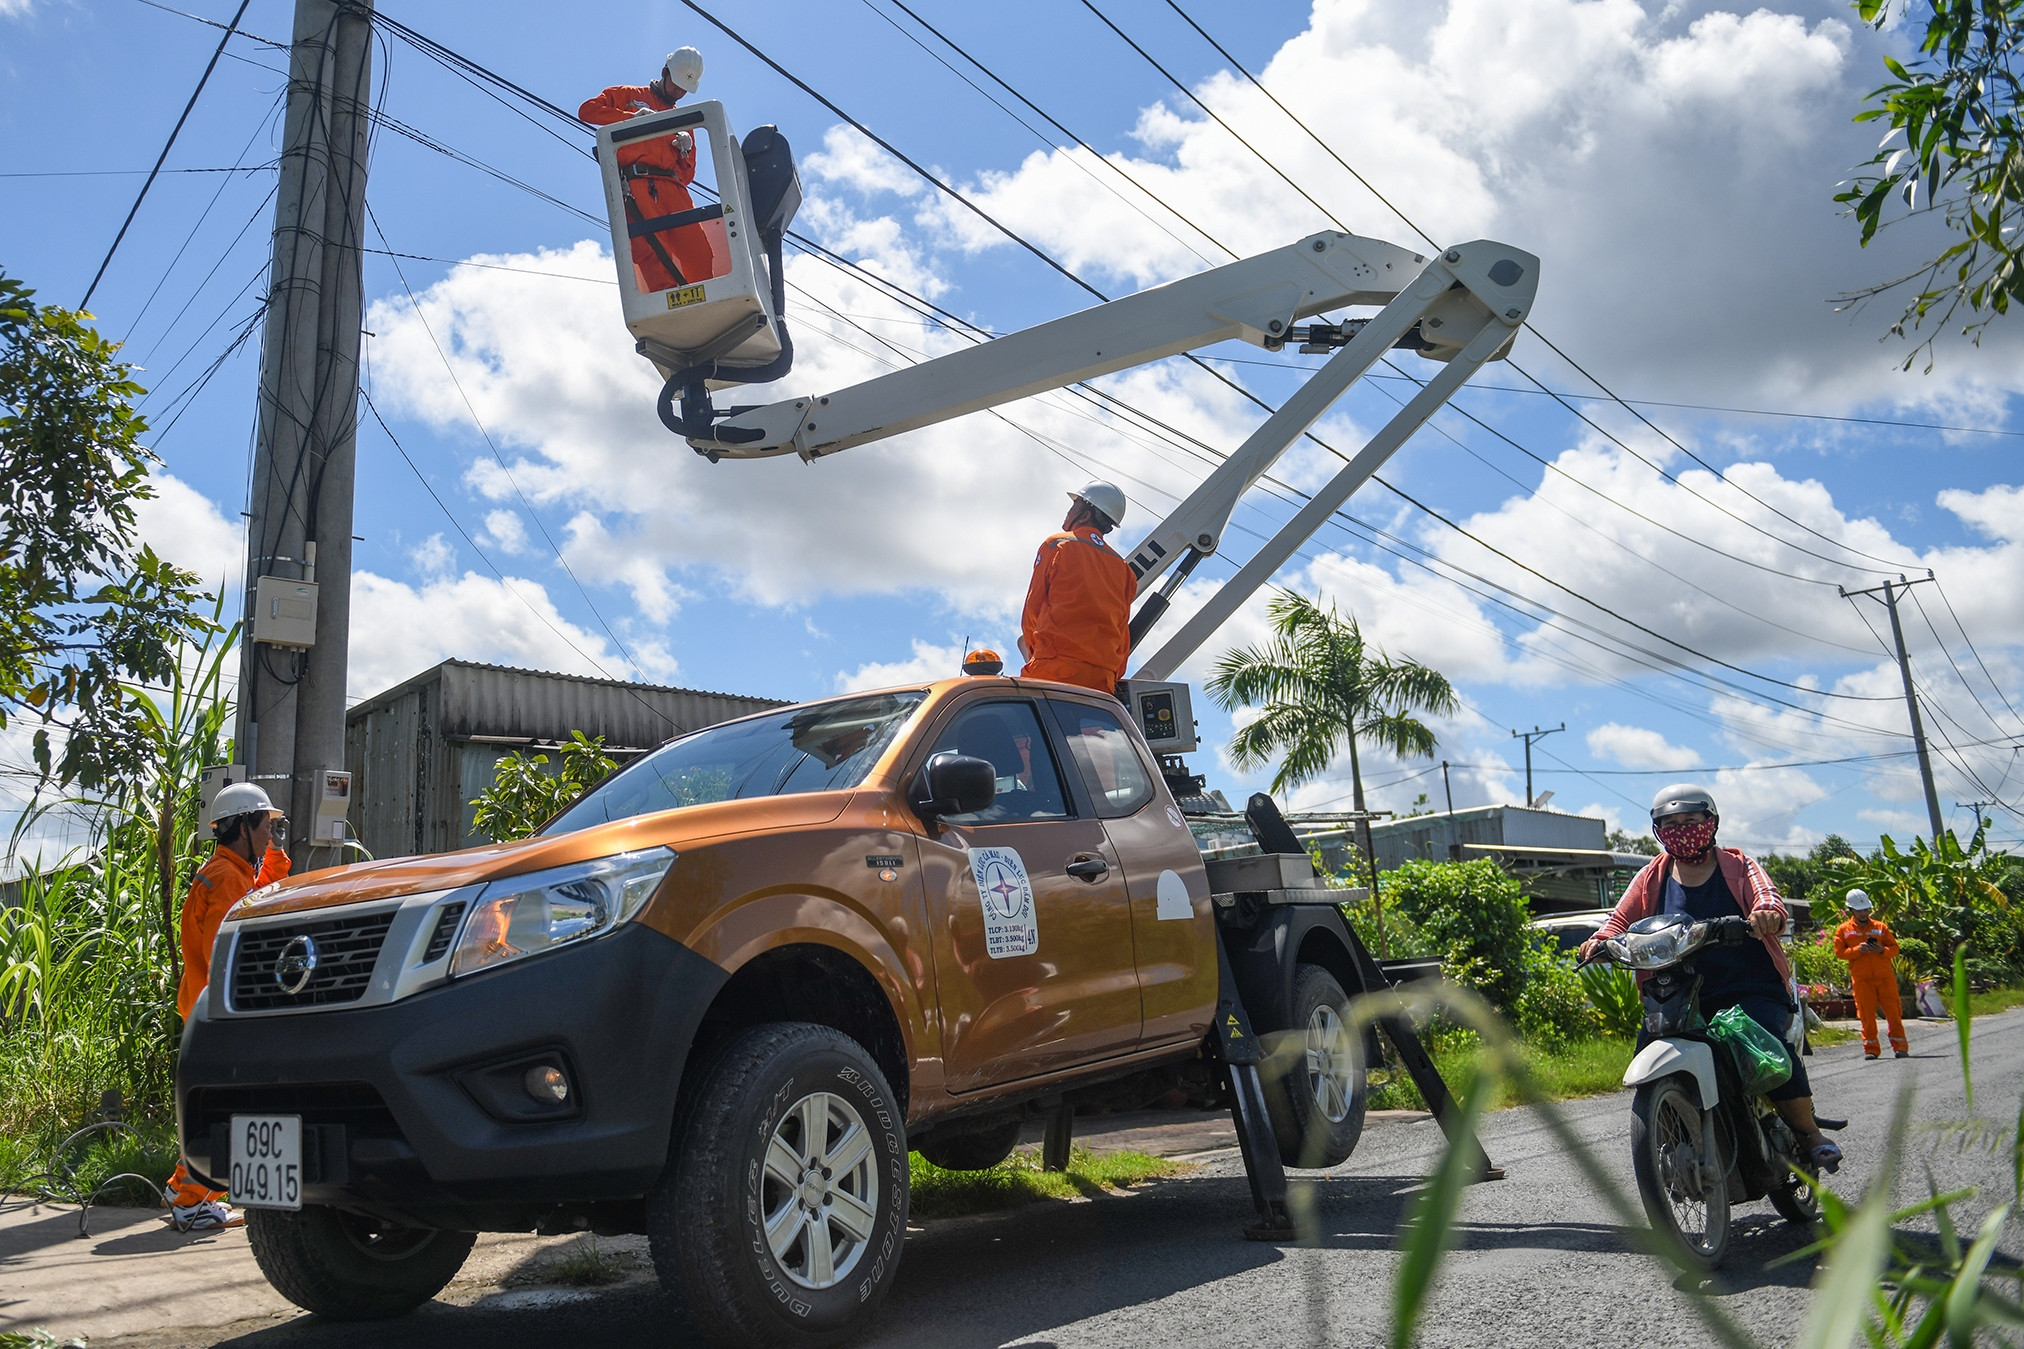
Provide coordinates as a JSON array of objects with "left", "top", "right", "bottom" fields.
[{"left": 164, "top": 783, "right": 289, "bottom": 1232}]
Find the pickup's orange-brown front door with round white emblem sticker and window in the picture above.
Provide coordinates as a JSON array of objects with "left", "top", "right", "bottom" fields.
[{"left": 913, "top": 698, "right": 1140, "bottom": 1092}]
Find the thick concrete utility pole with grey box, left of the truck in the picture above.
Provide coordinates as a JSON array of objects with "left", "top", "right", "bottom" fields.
[{"left": 235, "top": 0, "right": 372, "bottom": 870}]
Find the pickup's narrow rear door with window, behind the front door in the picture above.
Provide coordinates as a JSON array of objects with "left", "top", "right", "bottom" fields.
[{"left": 1046, "top": 698, "right": 1216, "bottom": 1048}]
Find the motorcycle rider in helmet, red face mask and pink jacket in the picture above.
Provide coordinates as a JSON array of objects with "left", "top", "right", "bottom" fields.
[{"left": 1581, "top": 783, "right": 1842, "bottom": 1171}]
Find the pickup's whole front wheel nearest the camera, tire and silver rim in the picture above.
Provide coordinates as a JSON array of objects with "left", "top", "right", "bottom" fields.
[{"left": 646, "top": 1021, "right": 907, "bottom": 1347}]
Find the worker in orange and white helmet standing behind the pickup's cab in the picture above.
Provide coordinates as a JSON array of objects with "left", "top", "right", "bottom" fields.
[{"left": 1018, "top": 483, "right": 1137, "bottom": 694}]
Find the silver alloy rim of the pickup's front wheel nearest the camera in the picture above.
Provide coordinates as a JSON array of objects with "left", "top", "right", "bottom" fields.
[{"left": 761, "top": 1092, "right": 878, "bottom": 1290}]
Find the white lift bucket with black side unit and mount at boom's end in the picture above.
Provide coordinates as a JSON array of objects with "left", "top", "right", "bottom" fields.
[{"left": 597, "top": 99, "right": 802, "bottom": 437}]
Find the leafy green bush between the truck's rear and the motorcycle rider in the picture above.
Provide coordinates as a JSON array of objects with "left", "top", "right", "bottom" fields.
[{"left": 1384, "top": 860, "right": 1532, "bottom": 1011}]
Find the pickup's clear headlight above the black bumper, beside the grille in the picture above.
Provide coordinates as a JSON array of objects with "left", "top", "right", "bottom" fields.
[{"left": 449, "top": 847, "right": 674, "bottom": 977}]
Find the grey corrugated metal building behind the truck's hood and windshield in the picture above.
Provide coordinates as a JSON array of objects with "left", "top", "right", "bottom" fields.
[{"left": 344, "top": 661, "right": 783, "bottom": 858}]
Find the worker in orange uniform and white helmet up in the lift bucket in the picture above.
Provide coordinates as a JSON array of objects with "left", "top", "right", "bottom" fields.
[{"left": 577, "top": 47, "right": 716, "bottom": 291}]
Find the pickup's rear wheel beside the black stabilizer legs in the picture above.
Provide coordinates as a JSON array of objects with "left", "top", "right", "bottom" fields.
[{"left": 1265, "top": 965, "right": 1368, "bottom": 1167}]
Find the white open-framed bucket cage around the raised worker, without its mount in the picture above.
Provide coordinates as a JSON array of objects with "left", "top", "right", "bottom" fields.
[{"left": 597, "top": 99, "right": 799, "bottom": 376}]
